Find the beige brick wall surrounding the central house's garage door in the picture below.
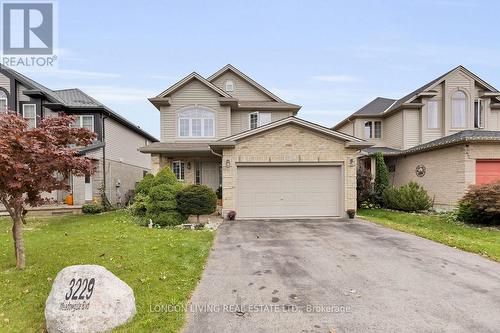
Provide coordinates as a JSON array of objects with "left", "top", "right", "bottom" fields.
[{"left": 222, "top": 124, "right": 357, "bottom": 217}]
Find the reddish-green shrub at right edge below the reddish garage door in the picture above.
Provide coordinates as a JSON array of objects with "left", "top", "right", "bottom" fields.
[{"left": 457, "top": 182, "right": 500, "bottom": 225}]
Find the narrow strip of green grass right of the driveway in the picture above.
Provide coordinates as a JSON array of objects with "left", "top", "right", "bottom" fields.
[{"left": 358, "top": 209, "right": 500, "bottom": 261}]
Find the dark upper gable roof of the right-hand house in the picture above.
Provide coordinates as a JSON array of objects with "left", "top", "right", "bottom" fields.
[{"left": 333, "top": 65, "right": 498, "bottom": 129}]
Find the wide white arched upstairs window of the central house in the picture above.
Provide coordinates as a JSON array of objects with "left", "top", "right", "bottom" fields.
[{"left": 178, "top": 107, "right": 215, "bottom": 138}]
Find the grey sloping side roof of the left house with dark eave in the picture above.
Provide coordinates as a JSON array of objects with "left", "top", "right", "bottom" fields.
[{"left": 54, "top": 88, "right": 158, "bottom": 142}]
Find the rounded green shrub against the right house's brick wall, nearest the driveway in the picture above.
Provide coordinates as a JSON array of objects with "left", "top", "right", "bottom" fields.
[{"left": 383, "top": 182, "right": 433, "bottom": 212}]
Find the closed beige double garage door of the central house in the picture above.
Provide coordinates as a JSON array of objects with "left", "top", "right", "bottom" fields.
[{"left": 237, "top": 166, "right": 342, "bottom": 218}]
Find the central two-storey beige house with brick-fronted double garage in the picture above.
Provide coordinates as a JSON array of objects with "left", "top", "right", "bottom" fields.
[{"left": 141, "top": 65, "right": 372, "bottom": 218}]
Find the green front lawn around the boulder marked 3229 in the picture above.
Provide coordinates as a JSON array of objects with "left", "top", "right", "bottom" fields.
[{"left": 0, "top": 212, "right": 213, "bottom": 332}]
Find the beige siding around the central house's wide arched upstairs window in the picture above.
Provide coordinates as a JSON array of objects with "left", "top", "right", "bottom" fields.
[{"left": 160, "top": 80, "right": 231, "bottom": 142}]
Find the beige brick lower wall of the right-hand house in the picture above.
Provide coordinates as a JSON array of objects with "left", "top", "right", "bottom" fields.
[{"left": 387, "top": 143, "right": 500, "bottom": 210}]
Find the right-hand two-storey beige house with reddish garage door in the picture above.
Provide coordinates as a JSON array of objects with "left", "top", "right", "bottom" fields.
[{"left": 333, "top": 66, "right": 500, "bottom": 210}]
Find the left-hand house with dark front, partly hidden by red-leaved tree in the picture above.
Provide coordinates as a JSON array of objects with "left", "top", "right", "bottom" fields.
[{"left": 0, "top": 66, "right": 158, "bottom": 206}]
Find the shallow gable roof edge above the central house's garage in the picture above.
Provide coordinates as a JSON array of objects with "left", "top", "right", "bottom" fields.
[{"left": 216, "top": 116, "right": 373, "bottom": 148}]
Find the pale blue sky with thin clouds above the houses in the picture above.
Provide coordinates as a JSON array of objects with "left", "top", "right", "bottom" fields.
[{"left": 22, "top": 0, "right": 500, "bottom": 137}]
